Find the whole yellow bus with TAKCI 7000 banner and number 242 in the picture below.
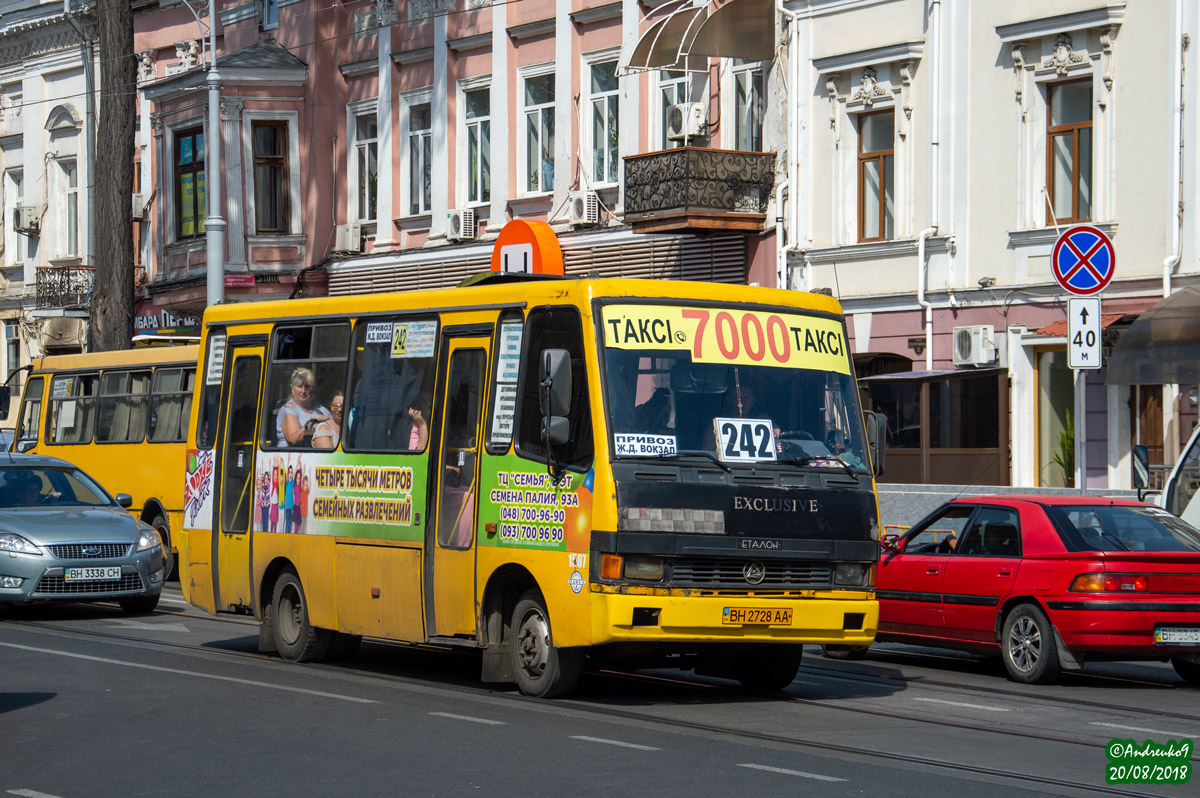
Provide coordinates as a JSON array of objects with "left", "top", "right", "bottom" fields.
[{"left": 179, "top": 223, "right": 880, "bottom": 696}]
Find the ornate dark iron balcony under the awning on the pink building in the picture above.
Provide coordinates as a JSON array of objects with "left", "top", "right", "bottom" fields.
[{"left": 625, "top": 146, "right": 775, "bottom": 233}]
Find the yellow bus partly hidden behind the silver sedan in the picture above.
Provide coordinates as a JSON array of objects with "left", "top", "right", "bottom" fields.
[{"left": 13, "top": 344, "right": 199, "bottom": 575}]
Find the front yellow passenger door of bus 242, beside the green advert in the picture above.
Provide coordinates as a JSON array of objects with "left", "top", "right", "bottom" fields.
[{"left": 425, "top": 337, "right": 491, "bottom": 637}]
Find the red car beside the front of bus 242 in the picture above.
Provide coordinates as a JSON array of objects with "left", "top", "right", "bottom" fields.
[{"left": 849, "top": 496, "right": 1200, "bottom": 684}]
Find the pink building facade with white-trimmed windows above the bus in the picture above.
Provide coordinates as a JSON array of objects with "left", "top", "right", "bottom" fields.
[{"left": 136, "top": 0, "right": 782, "bottom": 317}]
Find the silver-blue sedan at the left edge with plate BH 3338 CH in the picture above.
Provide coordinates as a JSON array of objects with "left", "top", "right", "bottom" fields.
[{"left": 0, "top": 455, "right": 166, "bottom": 613}]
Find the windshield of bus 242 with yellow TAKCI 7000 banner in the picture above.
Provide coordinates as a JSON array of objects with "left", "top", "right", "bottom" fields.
[{"left": 602, "top": 304, "right": 868, "bottom": 469}]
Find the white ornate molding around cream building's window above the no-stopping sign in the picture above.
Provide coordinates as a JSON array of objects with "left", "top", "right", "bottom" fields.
[{"left": 996, "top": 2, "right": 1126, "bottom": 230}]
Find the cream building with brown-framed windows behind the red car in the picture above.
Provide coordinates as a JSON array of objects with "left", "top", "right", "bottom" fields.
[{"left": 782, "top": 0, "right": 1200, "bottom": 488}]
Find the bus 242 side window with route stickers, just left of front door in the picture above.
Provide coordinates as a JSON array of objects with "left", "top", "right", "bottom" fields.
[{"left": 342, "top": 317, "right": 438, "bottom": 451}]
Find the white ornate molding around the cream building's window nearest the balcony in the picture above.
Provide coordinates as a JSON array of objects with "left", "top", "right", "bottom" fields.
[{"left": 812, "top": 41, "right": 925, "bottom": 246}]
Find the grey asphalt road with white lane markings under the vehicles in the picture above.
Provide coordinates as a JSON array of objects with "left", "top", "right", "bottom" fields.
[{"left": 0, "top": 586, "right": 1200, "bottom": 798}]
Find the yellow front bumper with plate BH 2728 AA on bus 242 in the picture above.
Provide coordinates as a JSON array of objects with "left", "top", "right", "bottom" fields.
[{"left": 592, "top": 593, "right": 880, "bottom": 646}]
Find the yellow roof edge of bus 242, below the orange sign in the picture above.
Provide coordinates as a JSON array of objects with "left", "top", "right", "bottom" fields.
[{"left": 204, "top": 277, "right": 842, "bottom": 325}]
